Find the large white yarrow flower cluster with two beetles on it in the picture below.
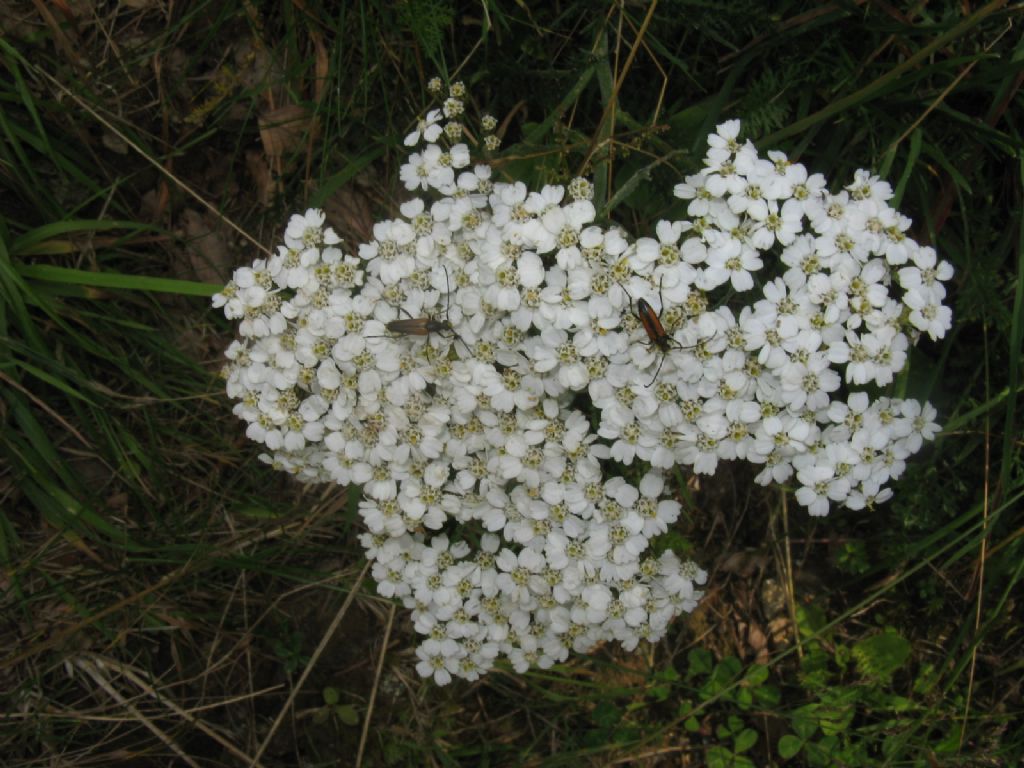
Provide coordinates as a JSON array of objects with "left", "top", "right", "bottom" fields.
[{"left": 214, "top": 79, "right": 951, "bottom": 684}]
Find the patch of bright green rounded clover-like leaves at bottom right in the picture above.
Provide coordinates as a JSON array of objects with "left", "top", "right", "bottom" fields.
[{"left": 671, "top": 609, "right": 1007, "bottom": 768}]
